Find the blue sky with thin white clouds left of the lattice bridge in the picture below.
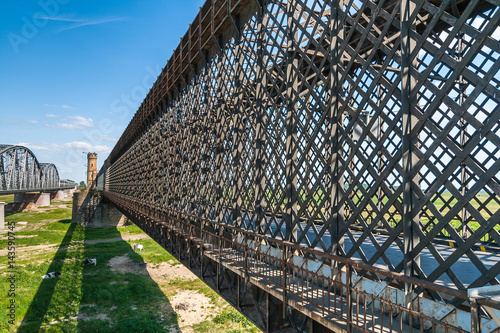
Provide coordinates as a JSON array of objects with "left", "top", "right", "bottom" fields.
[{"left": 0, "top": 0, "right": 204, "bottom": 182}]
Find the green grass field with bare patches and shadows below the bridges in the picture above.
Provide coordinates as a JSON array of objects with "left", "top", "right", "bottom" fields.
[{"left": 0, "top": 198, "right": 258, "bottom": 333}]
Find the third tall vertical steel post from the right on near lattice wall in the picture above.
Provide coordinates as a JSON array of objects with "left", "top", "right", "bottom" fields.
[{"left": 284, "top": 0, "right": 299, "bottom": 242}]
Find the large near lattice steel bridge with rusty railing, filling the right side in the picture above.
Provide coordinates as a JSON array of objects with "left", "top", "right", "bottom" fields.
[{"left": 98, "top": 0, "right": 500, "bottom": 332}]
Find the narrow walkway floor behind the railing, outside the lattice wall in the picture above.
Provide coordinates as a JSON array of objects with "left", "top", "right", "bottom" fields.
[{"left": 184, "top": 229, "right": 454, "bottom": 333}]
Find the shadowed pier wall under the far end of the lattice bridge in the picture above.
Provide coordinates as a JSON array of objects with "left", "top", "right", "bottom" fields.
[{"left": 72, "top": 191, "right": 126, "bottom": 228}]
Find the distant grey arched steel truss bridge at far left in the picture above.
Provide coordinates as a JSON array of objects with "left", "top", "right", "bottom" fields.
[{"left": 0, "top": 145, "right": 76, "bottom": 194}]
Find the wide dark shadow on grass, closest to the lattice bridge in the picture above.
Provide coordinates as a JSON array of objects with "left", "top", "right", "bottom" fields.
[{"left": 78, "top": 228, "right": 178, "bottom": 332}]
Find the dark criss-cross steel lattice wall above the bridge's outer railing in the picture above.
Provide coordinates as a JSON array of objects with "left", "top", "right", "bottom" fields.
[{"left": 105, "top": 0, "right": 500, "bottom": 330}]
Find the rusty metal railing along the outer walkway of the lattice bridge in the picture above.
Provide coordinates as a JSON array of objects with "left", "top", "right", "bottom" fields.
[{"left": 104, "top": 188, "right": 500, "bottom": 332}]
